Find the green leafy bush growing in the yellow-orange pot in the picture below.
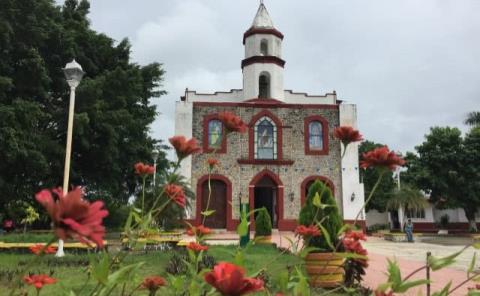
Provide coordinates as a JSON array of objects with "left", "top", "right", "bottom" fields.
[{"left": 299, "top": 180, "right": 343, "bottom": 251}]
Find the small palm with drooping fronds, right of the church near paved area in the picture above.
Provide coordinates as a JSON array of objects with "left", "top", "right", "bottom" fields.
[{"left": 387, "top": 185, "right": 428, "bottom": 225}]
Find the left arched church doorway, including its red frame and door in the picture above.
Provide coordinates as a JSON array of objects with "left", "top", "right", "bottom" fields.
[{"left": 196, "top": 174, "right": 232, "bottom": 229}]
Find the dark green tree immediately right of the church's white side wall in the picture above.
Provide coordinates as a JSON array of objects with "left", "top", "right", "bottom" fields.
[{"left": 359, "top": 141, "right": 395, "bottom": 213}]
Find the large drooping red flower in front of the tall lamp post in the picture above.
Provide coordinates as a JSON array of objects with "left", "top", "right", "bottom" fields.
[{"left": 35, "top": 187, "right": 108, "bottom": 247}]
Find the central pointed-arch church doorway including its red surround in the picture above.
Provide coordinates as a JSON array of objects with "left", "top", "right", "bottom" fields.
[{"left": 249, "top": 169, "right": 283, "bottom": 228}]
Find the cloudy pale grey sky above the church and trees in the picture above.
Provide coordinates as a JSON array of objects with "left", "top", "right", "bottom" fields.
[{"left": 79, "top": 0, "right": 480, "bottom": 155}]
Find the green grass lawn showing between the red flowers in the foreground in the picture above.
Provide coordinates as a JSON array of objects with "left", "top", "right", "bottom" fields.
[{"left": 0, "top": 246, "right": 301, "bottom": 296}]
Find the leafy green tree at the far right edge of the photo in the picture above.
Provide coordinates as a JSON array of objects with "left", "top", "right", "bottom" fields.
[{"left": 409, "top": 127, "right": 480, "bottom": 231}]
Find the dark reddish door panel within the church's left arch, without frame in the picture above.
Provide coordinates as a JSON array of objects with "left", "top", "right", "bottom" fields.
[{"left": 201, "top": 180, "right": 227, "bottom": 229}]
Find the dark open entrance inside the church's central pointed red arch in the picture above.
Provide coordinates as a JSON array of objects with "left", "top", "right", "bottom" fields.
[{"left": 253, "top": 176, "right": 278, "bottom": 228}]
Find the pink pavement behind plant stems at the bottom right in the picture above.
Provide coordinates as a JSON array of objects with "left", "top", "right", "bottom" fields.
[{"left": 364, "top": 253, "right": 473, "bottom": 296}]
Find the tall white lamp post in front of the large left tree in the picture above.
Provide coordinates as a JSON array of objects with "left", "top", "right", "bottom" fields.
[{"left": 55, "top": 59, "right": 85, "bottom": 257}]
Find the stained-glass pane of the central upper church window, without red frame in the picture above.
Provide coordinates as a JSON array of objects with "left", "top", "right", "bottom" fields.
[{"left": 254, "top": 116, "right": 277, "bottom": 159}]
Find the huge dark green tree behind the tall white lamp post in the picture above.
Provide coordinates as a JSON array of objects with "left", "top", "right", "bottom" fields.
[{"left": 0, "top": 0, "right": 167, "bottom": 212}]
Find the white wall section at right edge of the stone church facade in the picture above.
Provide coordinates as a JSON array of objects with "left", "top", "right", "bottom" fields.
[{"left": 339, "top": 104, "right": 365, "bottom": 220}]
